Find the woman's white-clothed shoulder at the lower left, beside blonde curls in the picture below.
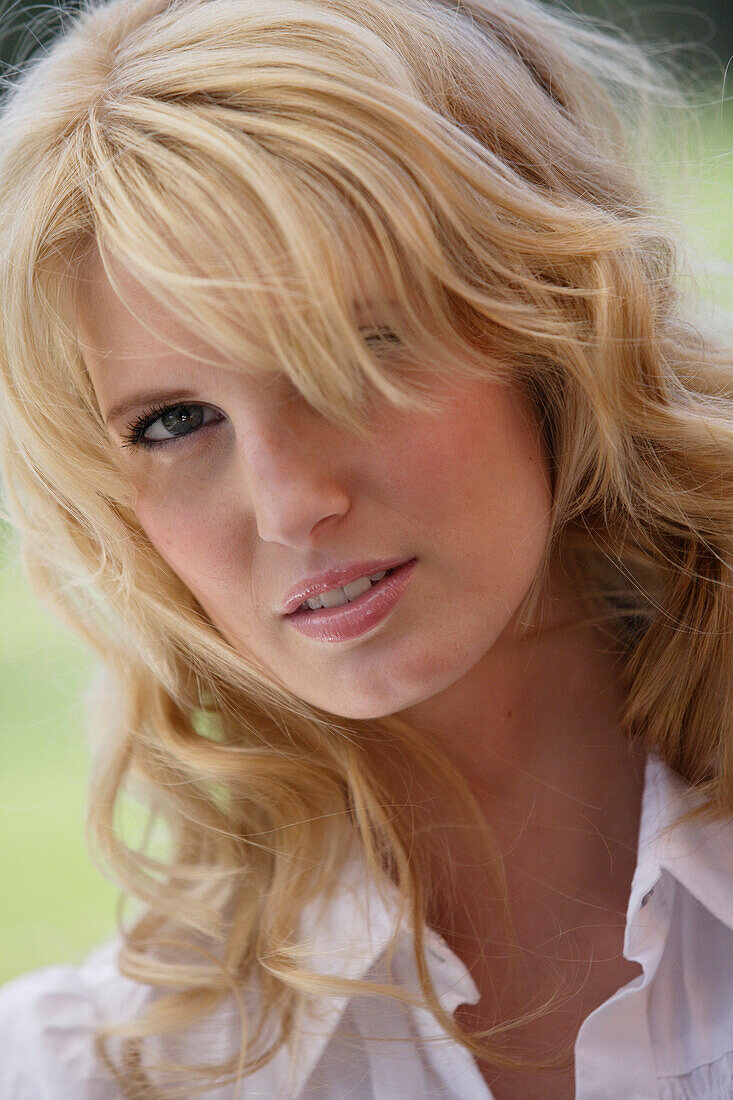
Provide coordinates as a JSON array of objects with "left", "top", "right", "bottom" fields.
[{"left": 0, "top": 938, "right": 141, "bottom": 1100}]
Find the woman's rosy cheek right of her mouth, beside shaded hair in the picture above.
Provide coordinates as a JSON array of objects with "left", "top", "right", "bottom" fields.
[{"left": 393, "top": 382, "right": 553, "bottom": 655}]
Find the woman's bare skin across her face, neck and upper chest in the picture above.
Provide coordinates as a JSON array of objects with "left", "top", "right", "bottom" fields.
[{"left": 80, "top": 251, "right": 643, "bottom": 1100}]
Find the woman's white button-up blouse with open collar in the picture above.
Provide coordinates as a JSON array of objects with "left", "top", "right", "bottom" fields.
[{"left": 0, "top": 755, "right": 733, "bottom": 1100}]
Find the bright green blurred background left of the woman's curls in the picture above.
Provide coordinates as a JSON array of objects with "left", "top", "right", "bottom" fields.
[{"left": 0, "top": 532, "right": 116, "bottom": 981}]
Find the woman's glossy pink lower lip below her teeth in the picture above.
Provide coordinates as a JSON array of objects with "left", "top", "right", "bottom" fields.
[{"left": 280, "top": 558, "right": 417, "bottom": 641}]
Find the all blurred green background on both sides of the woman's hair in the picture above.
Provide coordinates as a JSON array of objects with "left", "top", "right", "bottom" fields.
[{"left": 0, "top": 0, "right": 733, "bottom": 982}]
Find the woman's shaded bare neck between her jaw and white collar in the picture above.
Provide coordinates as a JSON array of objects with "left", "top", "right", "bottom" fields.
[{"left": 383, "top": 558, "right": 645, "bottom": 998}]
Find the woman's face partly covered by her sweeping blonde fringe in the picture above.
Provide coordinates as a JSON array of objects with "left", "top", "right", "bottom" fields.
[{"left": 81, "top": 261, "right": 551, "bottom": 718}]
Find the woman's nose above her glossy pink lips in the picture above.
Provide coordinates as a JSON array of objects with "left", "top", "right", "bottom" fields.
[{"left": 238, "top": 415, "right": 353, "bottom": 547}]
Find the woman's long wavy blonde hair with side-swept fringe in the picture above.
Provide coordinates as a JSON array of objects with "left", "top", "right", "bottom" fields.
[{"left": 0, "top": 0, "right": 733, "bottom": 1097}]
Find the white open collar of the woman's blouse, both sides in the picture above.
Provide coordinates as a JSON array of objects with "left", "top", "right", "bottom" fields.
[{"left": 279, "top": 754, "right": 733, "bottom": 1096}]
